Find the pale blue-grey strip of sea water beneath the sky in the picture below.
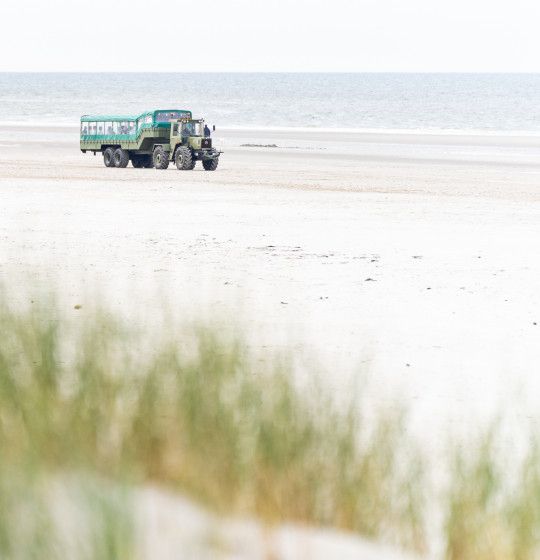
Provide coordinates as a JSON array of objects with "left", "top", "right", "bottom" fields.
[{"left": 0, "top": 73, "right": 540, "bottom": 133}]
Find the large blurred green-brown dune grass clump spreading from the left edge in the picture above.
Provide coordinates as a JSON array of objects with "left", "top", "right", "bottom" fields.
[{"left": 0, "top": 298, "right": 425, "bottom": 558}]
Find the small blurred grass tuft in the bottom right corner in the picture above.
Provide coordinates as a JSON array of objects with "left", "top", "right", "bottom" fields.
[{"left": 445, "top": 427, "right": 540, "bottom": 560}]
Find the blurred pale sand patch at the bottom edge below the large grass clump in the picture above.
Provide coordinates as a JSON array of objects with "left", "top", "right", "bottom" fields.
[{"left": 133, "top": 488, "right": 419, "bottom": 560}]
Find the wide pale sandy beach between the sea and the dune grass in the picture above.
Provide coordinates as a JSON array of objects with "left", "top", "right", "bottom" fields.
[{"left": 0, "top": 125, "right": 540, "bottom": 442}]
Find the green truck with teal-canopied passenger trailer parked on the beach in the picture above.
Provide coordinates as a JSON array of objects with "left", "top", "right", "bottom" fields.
[{"left": 81, "top": 109, "right": 221, "bottom": 171}]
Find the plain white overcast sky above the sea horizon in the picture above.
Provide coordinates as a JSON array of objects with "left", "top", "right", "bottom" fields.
[{"left": 0, "top": 0, "right": 540, "bottom": 72}]
